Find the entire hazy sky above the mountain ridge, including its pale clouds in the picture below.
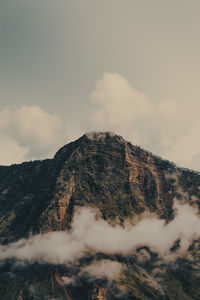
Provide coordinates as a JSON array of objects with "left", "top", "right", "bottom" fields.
[{"left": 0, "top": 0, "right": 200, "bottom": 170}]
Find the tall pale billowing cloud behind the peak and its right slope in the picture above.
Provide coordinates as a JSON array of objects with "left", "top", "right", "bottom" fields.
[{"left": 91, "top": 73, "right": 200, "bottom": 169}]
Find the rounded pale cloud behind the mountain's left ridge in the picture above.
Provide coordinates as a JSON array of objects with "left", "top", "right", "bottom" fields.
[{"left": 0, "top": 105, "right": 64, "bottom": 164}]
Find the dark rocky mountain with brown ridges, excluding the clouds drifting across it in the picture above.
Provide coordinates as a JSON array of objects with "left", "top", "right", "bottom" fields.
[{"left": 0, "top": 133, "right": 200, "bottom": 300}]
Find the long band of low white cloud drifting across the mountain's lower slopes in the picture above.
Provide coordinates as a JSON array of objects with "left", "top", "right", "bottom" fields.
[{"left": 0, "top": 203, "right": 200, "bottom": 272}]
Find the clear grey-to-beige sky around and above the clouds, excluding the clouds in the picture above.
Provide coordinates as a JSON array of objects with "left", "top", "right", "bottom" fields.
[{"left": 0, "top": 0, "right": 200, "bottom": 166}]
